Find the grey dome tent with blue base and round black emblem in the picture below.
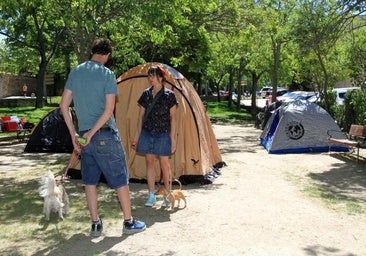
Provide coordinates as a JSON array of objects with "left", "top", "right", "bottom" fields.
[{"left": 260, "top": 100, "right": 349, "bottom": 154}]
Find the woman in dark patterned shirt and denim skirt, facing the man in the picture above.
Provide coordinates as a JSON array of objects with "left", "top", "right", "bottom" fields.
[{"left": 131, "top": 65, "right": 178, "bottom": 207}]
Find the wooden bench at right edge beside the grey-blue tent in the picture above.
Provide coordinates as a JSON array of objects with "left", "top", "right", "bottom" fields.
[{"left": 327, "top": 124, "right": 366, "bottom": 159}]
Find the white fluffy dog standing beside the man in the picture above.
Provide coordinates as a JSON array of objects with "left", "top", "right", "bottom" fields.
[{"left": 39, "top": 171, "right": 69, "bottom": 220}]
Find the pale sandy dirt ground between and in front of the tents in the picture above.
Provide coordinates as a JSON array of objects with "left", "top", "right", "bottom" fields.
[{"left": 0, "top": 124, "right": 366, "bottom": 256}]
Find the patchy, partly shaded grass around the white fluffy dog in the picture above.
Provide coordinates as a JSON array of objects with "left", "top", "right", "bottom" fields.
[{"left": 0, "top": 166, "right": 127, "bottom": 255}]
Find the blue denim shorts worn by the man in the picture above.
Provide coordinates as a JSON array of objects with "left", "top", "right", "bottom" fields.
[{"left": 79, "top": 129, "right": 129, "bottom": 189}]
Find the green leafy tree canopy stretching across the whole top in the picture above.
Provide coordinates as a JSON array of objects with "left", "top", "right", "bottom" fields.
[{"left": 0, "top": 0, "right": 366, "bottom": 107}]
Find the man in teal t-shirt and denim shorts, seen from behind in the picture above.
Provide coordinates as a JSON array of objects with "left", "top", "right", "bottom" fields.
[{"left": 60, "top": 39, "right": 146, "bottom": 236}]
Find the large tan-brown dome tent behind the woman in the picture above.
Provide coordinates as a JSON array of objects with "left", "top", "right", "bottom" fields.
[{"left": 115, "top": 63, "right": 224, "bottom": 182}]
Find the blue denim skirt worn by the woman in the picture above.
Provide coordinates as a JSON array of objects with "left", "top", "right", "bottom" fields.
[{"left": 136, "top": 130, "right": 172, "bottom": 156}]
